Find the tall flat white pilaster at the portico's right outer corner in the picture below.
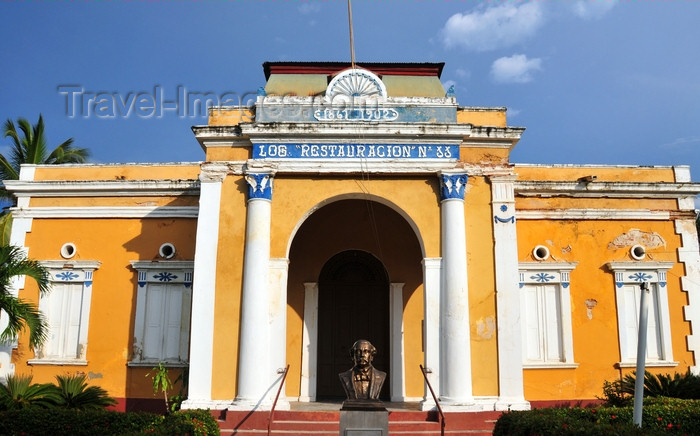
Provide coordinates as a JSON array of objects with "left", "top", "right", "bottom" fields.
[{"left": 490, "top": 175, "right": 530, "bottom": 410}]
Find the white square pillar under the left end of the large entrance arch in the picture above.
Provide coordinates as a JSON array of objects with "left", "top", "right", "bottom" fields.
[{"left": 269, "top": 258, "right": 289, "bottom": 410}]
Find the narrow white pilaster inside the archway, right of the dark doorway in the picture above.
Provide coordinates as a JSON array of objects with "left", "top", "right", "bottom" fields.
[{"left": 389, "top": 283, "right": 406, "bottom": 402}]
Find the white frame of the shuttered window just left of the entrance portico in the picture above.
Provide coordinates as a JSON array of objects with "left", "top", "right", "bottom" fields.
[{"left": 128, "top": 260, "right": 194, "bottom": 367}]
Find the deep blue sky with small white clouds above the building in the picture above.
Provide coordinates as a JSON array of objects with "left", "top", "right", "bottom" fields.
[{"left": 0, "top": 0, "right": 700, "bottom": 187}]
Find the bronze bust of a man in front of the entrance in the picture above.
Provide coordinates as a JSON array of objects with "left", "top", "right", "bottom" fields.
[{"left": 338, "top": 339, "right": 386, "bottom": 400}]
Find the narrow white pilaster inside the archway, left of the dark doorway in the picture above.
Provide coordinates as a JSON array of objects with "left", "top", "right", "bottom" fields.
[{"left": 299, "top": 283, "right": 318, "bottom": 401}]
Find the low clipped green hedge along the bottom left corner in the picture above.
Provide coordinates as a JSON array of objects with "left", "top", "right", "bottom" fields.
[{"left": 0, "top": 408, "right": 219, "bottom": 436}]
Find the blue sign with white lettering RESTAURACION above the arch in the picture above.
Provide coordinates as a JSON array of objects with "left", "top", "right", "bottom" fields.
[{"left": 253, "top": 143, "right": 459, "bottom": 160}]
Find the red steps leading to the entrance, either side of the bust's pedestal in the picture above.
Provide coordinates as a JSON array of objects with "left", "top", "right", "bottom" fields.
[{"left": 219, "top": 409, "right": 501, "bottom": 436}]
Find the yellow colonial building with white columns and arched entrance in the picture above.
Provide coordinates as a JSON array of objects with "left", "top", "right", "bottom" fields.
[{"left": 0, "top": 62, "right": 700, "bottom": 411}]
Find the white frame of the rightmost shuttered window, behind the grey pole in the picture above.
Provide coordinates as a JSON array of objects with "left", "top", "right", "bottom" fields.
[{"left": 607, "top": 262, "right": 678, "bottom": 368}]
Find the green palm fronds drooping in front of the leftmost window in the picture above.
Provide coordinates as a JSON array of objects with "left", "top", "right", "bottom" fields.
[{"left": 0, "top": 245, "right": 49, "bottom": 348}]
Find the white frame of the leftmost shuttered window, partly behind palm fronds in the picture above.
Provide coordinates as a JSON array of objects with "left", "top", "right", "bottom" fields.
[{"left": 27, "top": 260, "right": 101, "bottom": 366}]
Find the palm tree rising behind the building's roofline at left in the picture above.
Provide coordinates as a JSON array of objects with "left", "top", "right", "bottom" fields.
[{"left": 0, "top": 114, "right": 90, "bottom": 197}]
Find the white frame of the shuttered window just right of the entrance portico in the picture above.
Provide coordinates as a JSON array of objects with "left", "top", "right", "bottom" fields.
[{"left": 518, "top": 262, "right": 578, "bottom": 369}]
